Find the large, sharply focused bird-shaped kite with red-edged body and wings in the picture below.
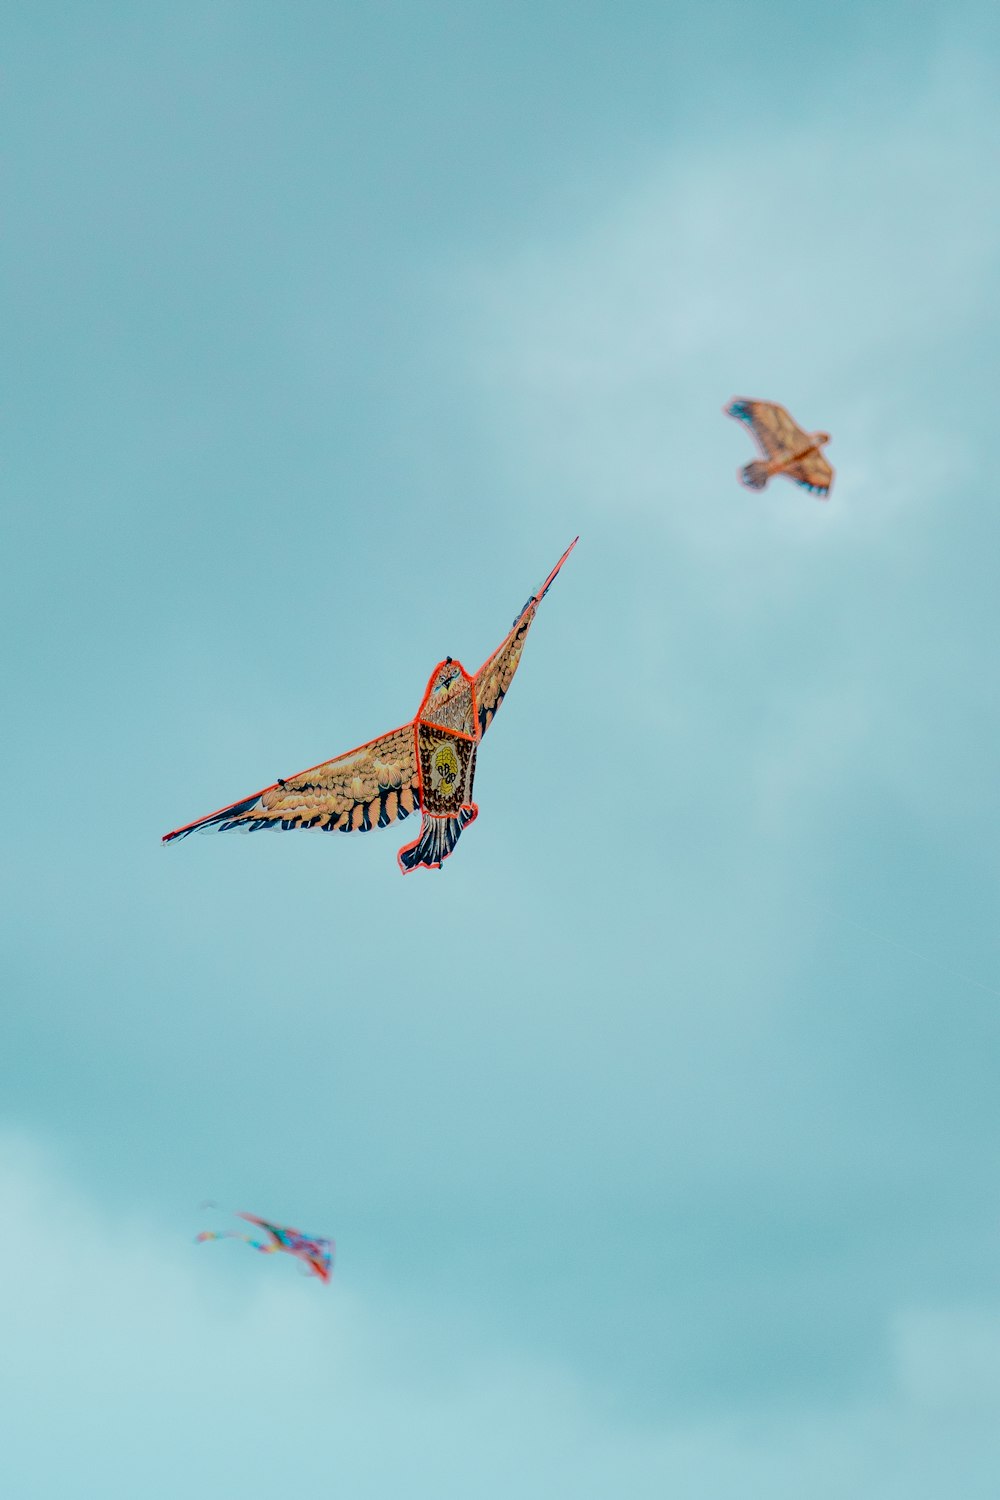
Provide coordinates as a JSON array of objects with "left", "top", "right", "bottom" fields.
[{"left": 163, "top": 537, "right": 579, "bottom": 875}]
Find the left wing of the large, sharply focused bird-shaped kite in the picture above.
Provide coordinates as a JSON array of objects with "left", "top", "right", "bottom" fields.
[{"left": 163, "top": 725, "right": 420, "bottom": 843}]
